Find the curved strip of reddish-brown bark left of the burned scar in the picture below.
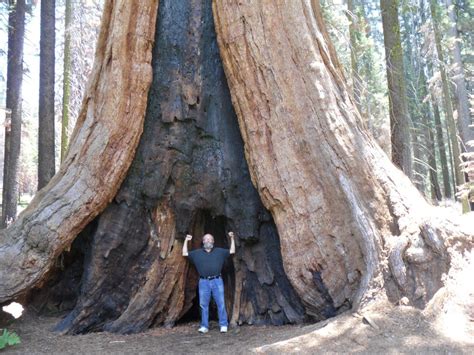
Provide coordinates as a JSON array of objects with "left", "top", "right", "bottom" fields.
[{"left": 0, "top": 0, "right": 157, "bottom": 302}]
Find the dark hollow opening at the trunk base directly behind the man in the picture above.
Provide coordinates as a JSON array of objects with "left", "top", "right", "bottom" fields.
[{"left": 178, "top": 210, "right": 235, "bottom": 323}]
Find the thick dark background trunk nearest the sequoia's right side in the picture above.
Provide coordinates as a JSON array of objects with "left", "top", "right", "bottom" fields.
[{"left": 380, "top": 0, "right": 412, "bottom": 178}]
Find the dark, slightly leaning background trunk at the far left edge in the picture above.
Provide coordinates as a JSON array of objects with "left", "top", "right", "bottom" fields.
[{"left": 2, "top": 0, "right": 26, "bottom": 228}]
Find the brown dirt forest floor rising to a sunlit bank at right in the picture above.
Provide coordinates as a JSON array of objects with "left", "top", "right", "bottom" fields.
[{"left": 0, "top": 249, "right": 474, "bottom": 354}]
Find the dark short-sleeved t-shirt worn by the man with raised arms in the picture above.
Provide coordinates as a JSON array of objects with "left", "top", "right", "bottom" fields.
[{"left": 188, "top": 248, "right": 230, "bottom": 277}]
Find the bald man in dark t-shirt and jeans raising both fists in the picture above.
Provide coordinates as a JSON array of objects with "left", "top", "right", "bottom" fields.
[{"left": 183, "top": 232, "right": 235, "bottom": 333}]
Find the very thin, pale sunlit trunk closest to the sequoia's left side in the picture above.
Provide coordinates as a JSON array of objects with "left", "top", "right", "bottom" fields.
[{"left": 61, "top": 0, "right": 73, "bottom": 162}]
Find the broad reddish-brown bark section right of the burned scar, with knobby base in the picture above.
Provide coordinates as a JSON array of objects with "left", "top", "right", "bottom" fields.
[{"left": 213, "top": 0, "right": 472, "bottom": 319}]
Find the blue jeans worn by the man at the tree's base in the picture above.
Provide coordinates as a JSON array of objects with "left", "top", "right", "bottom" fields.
[{"left": 199, "top": 277, "right": 228, "bottom": 329}]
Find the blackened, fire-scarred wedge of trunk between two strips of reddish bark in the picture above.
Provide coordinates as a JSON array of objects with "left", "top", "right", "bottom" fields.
[{"left": 30, "top": 0, "right": 305, "bottom": 334}]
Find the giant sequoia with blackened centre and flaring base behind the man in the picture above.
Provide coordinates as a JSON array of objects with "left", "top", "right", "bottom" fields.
[{"left": 0, "top": 0, "right": 472, "bottom": 333}]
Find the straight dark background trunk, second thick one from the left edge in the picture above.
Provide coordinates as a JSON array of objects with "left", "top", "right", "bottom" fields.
[{"left": 38, "top": 0, "right": 56, "bottom": 190}]
